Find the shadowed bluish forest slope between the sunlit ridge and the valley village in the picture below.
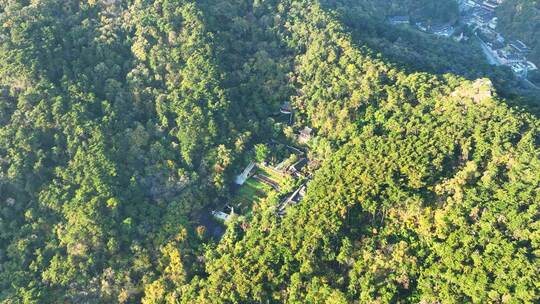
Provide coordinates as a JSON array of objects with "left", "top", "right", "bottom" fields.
[{"left": 321, "top": 0, "right": 540, "bottom": 114}]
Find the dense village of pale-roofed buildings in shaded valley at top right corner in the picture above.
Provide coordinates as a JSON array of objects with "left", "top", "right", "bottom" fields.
[{"left": 460, "top": 0, "right": 537, "bottom": 78}]
